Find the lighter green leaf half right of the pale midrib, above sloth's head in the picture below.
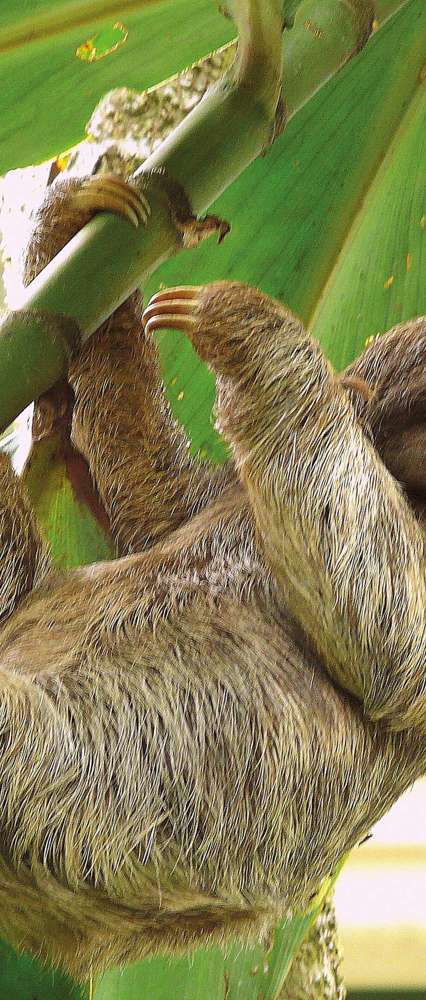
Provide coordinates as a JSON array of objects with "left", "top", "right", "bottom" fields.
[{"left": 312, "top": 72, "right": 426, "bottom": 368}]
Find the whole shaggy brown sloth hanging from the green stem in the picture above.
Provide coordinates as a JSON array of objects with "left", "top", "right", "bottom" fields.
[{"left": 0, "top": 178, "right": 426, "bottom": 979}]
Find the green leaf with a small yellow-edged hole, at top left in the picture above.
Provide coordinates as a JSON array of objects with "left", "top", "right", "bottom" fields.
[{"left": 0, "top": 0, "right": 235, "bottom": 173}]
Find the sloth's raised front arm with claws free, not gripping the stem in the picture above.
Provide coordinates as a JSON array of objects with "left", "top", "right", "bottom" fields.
[{"left": 144, "top": 282, "right": 426, "bottom": 734}]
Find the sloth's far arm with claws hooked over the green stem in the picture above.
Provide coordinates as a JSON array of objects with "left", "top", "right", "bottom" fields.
[{"left": 25, "top": 175, "right": 233, "bottom": 554}]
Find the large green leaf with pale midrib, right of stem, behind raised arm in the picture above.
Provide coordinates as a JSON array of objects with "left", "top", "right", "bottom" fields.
[{"left": 147, "top": 0, "right": 426, "bottom": 460}]
